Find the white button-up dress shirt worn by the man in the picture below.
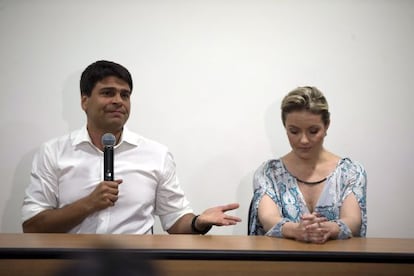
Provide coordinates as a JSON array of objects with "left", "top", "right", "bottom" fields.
[{"left": 22, "top": 126, "right": 193, "bottom": 234}]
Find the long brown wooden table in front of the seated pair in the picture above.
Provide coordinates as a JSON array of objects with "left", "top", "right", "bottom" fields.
[{"left": 0, "top": 234, "right": 414, "bottom": 276}]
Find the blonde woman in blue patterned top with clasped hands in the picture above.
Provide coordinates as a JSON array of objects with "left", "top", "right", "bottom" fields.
[{"left": 249, "top": 87, "right": 367, "bottom": 243}]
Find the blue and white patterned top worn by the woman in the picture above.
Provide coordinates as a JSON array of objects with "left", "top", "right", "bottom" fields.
[{"left": 249, "top": 158, "right": 367, "bottom": 239}]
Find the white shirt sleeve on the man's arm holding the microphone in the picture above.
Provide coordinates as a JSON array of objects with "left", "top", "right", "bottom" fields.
[{"left": 22, "top": 145, "right": 58, "bottom": 222}]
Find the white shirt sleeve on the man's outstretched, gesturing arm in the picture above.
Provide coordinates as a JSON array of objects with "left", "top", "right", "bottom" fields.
[{"left": 155, "top": 152, "right": 193, "bottom": 230}]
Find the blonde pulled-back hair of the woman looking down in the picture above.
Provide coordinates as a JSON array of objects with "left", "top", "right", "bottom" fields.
[{"left": 281, "top": 86, "right": 330, "bottom": 126}]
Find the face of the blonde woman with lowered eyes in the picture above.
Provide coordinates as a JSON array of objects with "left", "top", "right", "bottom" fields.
[{"left": 285, "top": 110, "right": 329, "bottom": 159}]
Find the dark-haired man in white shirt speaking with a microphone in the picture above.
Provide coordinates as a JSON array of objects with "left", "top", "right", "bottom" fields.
[{"left": 22, "top": 60, "right": 240, "bottom": 234}]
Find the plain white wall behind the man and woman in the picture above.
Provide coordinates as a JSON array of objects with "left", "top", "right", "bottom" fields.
[{"left": 0, "top": 0, "right": 414, "bottom": 238}]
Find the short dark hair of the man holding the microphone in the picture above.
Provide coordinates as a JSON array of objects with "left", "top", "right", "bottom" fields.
[{"left": 80, "top": 60, "right": 132, "bottom": 97}]
